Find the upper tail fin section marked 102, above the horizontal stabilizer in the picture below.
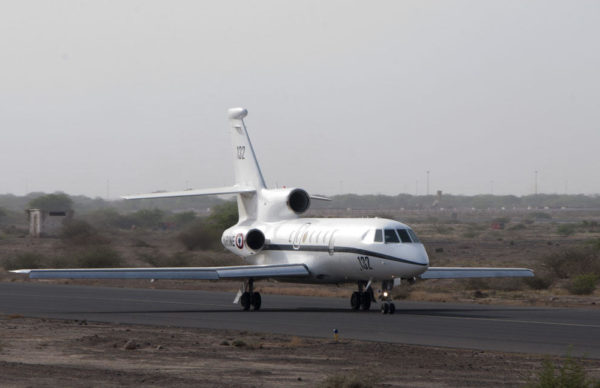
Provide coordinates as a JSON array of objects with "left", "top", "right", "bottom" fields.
[{"left": 228, "top": 108, "right": 267, "bottom": 190}]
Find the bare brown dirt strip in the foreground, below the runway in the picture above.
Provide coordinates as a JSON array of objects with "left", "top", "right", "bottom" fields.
[{"left": 0, "top": 316, "right": 600, "bottom": 387}]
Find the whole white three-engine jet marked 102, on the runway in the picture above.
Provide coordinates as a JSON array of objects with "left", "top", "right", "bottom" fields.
[{"left": 14, "top": 108, "right": 533, "bottom": 314}]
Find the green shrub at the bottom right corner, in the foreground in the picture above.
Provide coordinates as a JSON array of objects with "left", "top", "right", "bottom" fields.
[{"left": 527, "top": 355, "right": 600, "bottom": 388}]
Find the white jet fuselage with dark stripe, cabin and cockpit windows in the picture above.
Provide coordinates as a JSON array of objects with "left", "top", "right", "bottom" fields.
[{"left": 222, "top": 218, "right": 429, "bottom": 283}]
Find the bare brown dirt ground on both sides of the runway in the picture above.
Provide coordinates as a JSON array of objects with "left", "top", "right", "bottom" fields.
[{"left": 0, "top": 211, "right": 600, "bottom": 387}]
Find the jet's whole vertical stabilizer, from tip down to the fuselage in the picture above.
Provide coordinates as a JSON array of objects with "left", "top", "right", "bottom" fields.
[{"left": 228, "top": 108, "right": 267, "bottom": 222}]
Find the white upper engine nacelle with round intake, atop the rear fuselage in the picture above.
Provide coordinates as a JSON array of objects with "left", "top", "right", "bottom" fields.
[{"left": 258, "top": 188, "right": 310, "bottom": 220}]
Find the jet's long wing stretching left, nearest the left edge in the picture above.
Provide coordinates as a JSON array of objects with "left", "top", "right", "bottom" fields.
[{"left": 11, "top": 264, "right": 310, "bottom": 280}]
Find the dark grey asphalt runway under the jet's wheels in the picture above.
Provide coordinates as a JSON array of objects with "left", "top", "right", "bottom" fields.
[{"left": 0, "top": 283, "right": 600, "bottom": 359}]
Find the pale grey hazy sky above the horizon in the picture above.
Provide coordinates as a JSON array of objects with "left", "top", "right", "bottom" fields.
[{"left": 0, "top": 0, "right": 600, "bottom": 198}]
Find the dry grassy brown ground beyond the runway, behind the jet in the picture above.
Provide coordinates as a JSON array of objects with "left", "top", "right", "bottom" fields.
[{"left": 0, "top": 211, "right": 600, "bottom": 305}]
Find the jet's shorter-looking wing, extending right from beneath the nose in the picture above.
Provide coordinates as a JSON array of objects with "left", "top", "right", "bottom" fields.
[{"left": 420, "top": 267, "right": 534, "bottom": 279}]
